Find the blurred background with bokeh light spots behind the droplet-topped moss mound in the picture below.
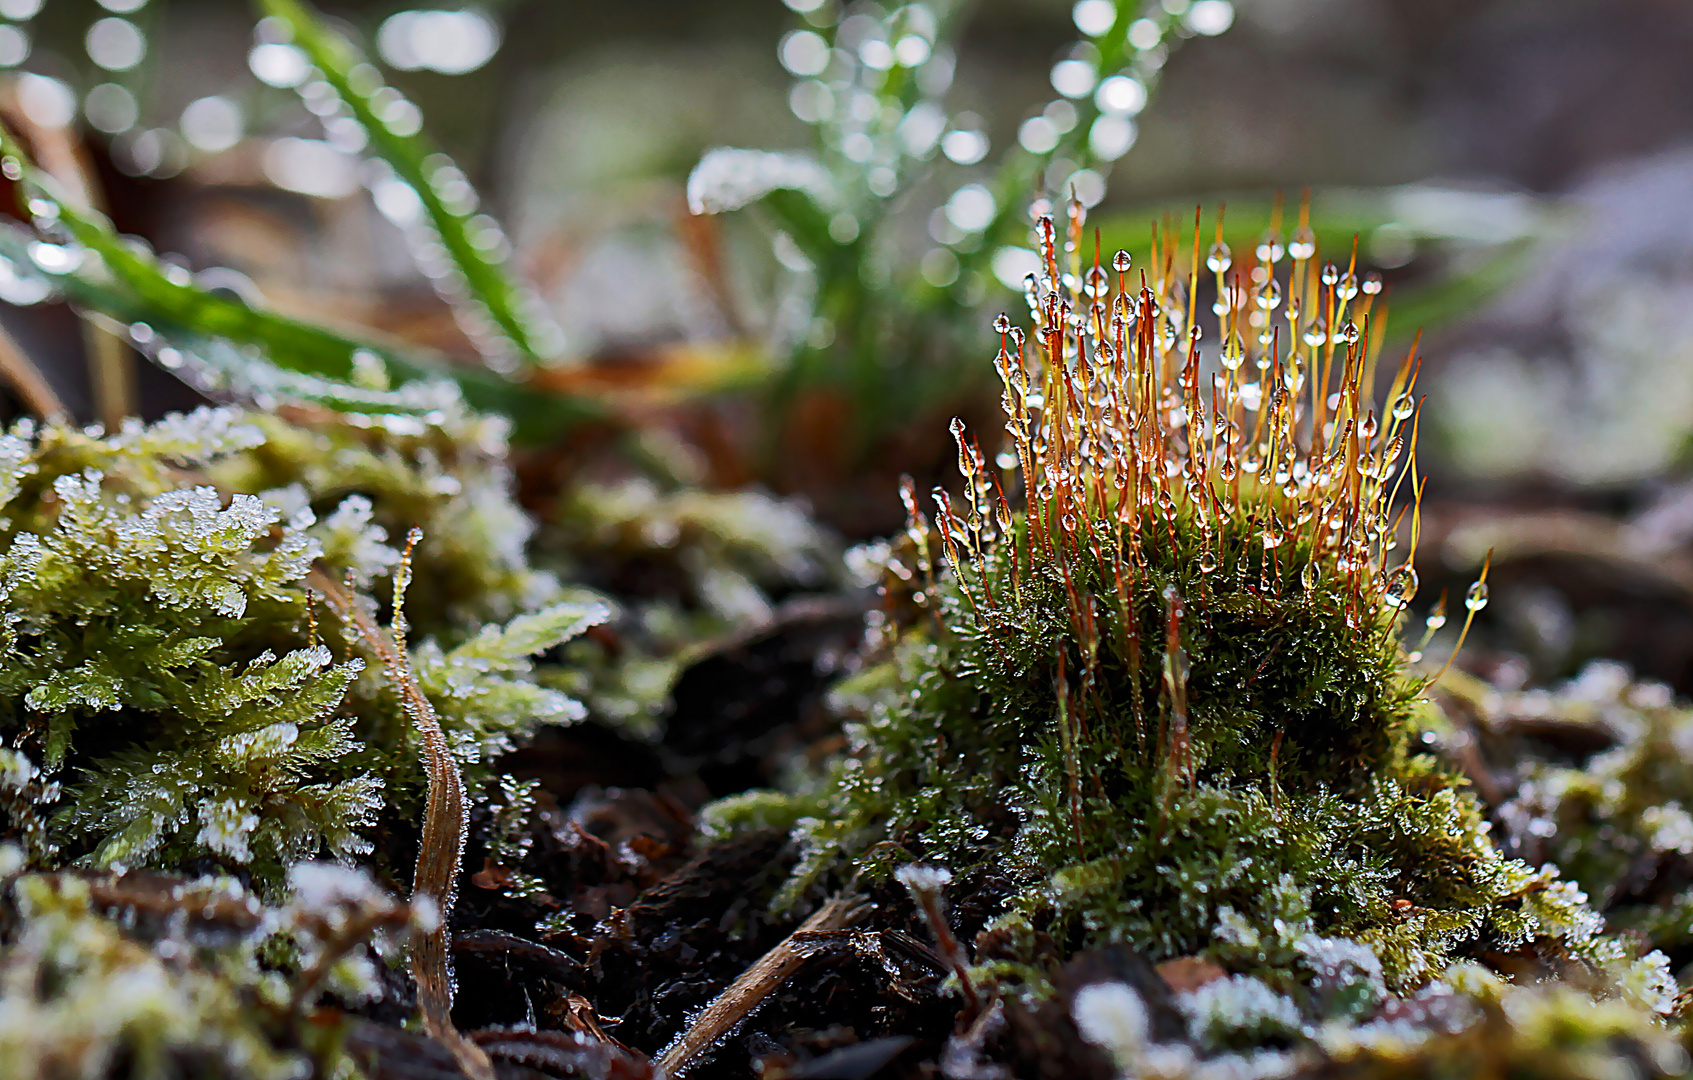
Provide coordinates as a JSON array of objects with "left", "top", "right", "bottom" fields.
[{"left": 0, "top": 0, "right": 1693, "bottom": 692}]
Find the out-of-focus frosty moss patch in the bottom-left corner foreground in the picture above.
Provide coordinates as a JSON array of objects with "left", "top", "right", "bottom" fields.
[{"left": 0, "top": 845, "right": 413, "bottom": 1080}]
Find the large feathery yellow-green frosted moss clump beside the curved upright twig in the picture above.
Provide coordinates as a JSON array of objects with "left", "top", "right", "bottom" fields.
[{"left": 0, "top": 410, "right": 606, "bottom": 884}]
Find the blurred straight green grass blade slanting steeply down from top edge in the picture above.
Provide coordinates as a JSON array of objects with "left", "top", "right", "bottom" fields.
[{"left": 259, "top": 0, "right": 562, "bottom": 371}]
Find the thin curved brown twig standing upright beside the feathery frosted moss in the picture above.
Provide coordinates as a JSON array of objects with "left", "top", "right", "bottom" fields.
[{"left": 306, "top": 562, "right": 494, "bottom": 1080}]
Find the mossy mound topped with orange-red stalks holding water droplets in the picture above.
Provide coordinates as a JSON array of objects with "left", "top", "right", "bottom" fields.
[{"left": 709, "top": 207, "right": 1669, "bottom": 1017}]
